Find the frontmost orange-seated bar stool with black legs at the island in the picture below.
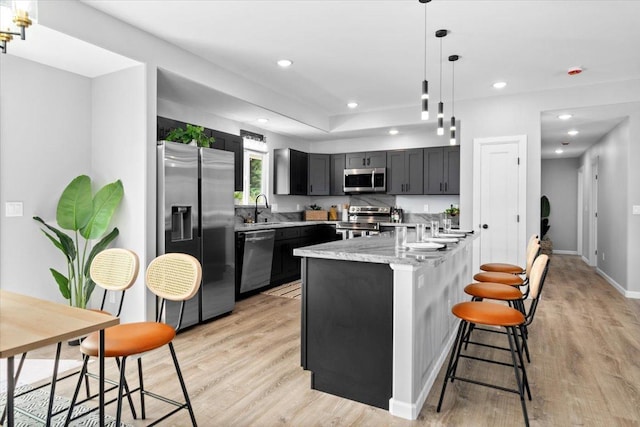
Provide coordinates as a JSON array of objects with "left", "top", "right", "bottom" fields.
[{"left": 437, "top": 301, "right": 531, "bottom": 427}]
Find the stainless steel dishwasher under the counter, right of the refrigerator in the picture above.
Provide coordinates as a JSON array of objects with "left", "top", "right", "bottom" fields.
[{"left": 240, "top": 230, "right": 276, "bottom": 293}]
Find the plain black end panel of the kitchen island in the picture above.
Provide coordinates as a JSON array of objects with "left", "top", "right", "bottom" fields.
[{"left": 302, "top": 258, "right": 393, "bottom": 409}]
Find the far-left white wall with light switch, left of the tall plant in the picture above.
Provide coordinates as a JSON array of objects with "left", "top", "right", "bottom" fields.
[{"left": 0, "top": 55, "right": 92, "bottom": 302}]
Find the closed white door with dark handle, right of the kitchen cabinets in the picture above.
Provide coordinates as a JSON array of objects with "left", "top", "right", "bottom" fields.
[{"left": 474, "top": 136, "right": 526, "bottom": 265}]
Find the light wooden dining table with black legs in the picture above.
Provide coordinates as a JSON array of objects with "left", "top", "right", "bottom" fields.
[{"left": 0, "top": 289, "right": 120, "bottom": 427}]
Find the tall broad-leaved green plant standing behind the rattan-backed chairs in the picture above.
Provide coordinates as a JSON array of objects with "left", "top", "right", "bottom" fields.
[{"left": 33, "top": 175, "right": 124, "bottom": 308}]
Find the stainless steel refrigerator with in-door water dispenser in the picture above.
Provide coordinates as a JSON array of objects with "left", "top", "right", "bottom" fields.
[{"left": 157, "top": 141, "right": 235, "bottom": 326}]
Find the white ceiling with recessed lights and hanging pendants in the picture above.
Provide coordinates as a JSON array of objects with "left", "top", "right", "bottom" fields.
[{"left": 6, "top": 0, "right": 640, "bottom": 157}]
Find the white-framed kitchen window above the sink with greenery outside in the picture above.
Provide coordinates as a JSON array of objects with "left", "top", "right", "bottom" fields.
[{"left": 234, "top": 138, "right": 269, "bottom": 205}]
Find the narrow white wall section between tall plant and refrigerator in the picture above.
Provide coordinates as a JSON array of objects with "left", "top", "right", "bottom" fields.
[{"left": 91, "top": 65, "right": 148, "bottom": 322}]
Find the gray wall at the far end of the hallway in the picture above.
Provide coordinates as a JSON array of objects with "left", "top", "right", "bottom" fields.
[{"left": 541, "top": 158, "right": 580, "bottom": 253}]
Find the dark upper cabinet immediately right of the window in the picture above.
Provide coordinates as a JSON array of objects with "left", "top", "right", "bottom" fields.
[{"left": 273, "top": 148, "right": 309, "bottom": 196}]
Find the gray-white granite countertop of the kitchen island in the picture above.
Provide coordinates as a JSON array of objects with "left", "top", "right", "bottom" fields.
[{"left": 293, "top": 231, "right": 477, "bottom": 266}]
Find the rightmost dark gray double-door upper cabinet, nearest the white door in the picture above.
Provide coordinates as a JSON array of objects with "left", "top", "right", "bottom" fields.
[{"left": 424, "top": 146, "right": 460, "bottom": 194}]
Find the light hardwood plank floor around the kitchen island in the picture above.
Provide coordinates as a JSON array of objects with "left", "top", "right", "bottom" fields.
[{"left": 25, "top": 255, "right": 640, "bottom": 427}]
